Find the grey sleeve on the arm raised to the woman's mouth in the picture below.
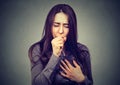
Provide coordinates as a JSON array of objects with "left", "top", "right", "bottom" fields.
[{"left": 28, "top": 45, "right": 59, "bottom": 85}]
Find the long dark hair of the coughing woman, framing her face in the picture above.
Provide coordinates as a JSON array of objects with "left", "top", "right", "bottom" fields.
[{"left": 29, "top": 4, "right": 80, "bottom": 64}]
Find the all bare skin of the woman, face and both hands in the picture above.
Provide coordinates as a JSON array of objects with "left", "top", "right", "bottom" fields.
[{"left": 51, "top": 12, "right": 85, "bottom": 82}]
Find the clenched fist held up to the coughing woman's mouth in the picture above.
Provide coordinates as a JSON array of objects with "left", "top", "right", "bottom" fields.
[{"left": 51, "top": 37, "right": 66, "bottom": 56}]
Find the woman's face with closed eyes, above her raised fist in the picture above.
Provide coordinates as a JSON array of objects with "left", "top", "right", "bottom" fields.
[{"left": 52, "top": 12, "right": 69, "bottom": 38}]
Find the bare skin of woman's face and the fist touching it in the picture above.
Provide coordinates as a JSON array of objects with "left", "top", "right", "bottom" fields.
[{"left": 51, "top": 12, "right": 69, "bottom": 56}]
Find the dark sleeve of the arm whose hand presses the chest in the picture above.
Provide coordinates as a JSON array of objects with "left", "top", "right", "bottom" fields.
[{"left": 78, "top": 45, "right": 93, "bottom": 85}]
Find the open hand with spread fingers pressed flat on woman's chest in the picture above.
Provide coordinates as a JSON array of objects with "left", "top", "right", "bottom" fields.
[{"left": 60, "top": 59, "right": 85, "bottom": 82}]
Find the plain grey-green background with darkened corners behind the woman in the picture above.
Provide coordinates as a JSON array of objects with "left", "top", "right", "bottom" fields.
[{"left": 0, "top": 0, "right": 120, "bottom": 85}]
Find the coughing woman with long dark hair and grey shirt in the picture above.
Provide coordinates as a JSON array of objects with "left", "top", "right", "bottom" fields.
[{"left": 29, "top": 4, "right": 93, "bottom": 85}]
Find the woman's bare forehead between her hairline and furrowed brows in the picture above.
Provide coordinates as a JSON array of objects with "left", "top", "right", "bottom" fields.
[{"left": 54, "top": 12, "right": 68, "bottom": 23}]
